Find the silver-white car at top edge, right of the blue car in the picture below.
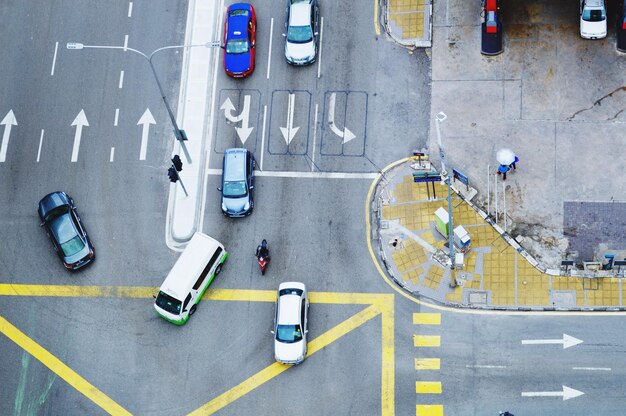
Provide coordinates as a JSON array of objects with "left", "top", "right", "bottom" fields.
[{"left": 283, "top": 0, "right": 319, "bottom": 65}]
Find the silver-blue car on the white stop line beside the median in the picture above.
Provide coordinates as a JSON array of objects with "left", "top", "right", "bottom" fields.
[{"left": 217, "top": 149, "right": 256, "bottom": 217}]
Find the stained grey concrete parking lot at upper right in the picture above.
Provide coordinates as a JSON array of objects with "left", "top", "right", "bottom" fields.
[{"left": 430, "top": 0, "right": 626, "bottom": 267}]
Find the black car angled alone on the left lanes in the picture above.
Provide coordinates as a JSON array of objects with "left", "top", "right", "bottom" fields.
[{"left": 37, "top": 192, "right": 96, "bottom": 270}]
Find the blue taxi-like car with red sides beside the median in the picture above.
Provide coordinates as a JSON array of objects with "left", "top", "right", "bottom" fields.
[{"left": 222, "top": 3, "right": 256, "bottom": 78}]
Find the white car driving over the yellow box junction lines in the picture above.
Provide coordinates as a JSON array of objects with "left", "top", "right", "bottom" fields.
[{"left": 272, "top": 282, "right": 309, "bottom": 364}]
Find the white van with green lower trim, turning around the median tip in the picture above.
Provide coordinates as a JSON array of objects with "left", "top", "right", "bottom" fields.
[{"left": 154, "top": 232, "right": 228, "bottom": 325}]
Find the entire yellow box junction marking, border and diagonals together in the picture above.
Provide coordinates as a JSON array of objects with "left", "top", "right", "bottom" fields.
[{"left": 0, "top": 284, "right": 395, "bottom": 416}]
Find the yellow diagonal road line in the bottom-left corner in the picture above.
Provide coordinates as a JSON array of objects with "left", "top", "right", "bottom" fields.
[{"left": 0, "top": 316, "right": 131, "bottom": 415}]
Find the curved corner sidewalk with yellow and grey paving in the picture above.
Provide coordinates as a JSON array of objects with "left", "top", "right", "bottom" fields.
[{"left": 371, "top": 158, "right": 626, "bottom": 310}]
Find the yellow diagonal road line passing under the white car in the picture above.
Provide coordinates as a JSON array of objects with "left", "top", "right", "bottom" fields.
[{"left": 189, "top": 305, "right": 382, "bottom": 416}]
